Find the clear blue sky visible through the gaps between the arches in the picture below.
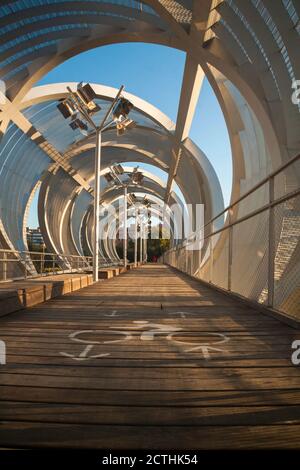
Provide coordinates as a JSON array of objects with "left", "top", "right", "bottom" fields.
[{"left": 28, "top": 43, "right": 232, "bottom": 227}]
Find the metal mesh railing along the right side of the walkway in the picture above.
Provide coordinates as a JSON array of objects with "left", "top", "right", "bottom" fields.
[{"left": 161, "top": 155, "right": 300, "bottom": 321}]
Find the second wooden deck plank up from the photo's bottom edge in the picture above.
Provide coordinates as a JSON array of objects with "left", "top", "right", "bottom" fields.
[{"left": 0, "top": 401, "right": 300, "bottom": 426}]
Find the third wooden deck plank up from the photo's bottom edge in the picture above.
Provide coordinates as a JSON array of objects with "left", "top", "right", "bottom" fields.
[{"left": 0, "top": 385, "right": 300, "bottom": 408}]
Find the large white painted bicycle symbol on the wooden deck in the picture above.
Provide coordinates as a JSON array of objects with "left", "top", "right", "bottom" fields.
[{"left": 60, "top": 320, "right": 229, "bottom": 361}]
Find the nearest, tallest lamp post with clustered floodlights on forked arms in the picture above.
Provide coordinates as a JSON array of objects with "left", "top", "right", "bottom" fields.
[{"left": 57, "top": 82, "right": 133, "bottom": 282}]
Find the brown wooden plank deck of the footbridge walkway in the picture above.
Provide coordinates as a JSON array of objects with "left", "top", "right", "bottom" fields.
[{"left": 0, "top": 265, "right": 300, "bottom": 449}]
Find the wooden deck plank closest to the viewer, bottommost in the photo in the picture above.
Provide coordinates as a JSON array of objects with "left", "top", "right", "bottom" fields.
[{"left": 0, "top": 421, "right": 300, "bottom": 450}]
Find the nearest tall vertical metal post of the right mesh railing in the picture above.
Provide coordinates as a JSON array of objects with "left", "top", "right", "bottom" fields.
[{"left": 268, "top": 176, "right": 275, "bottom": 307}]
